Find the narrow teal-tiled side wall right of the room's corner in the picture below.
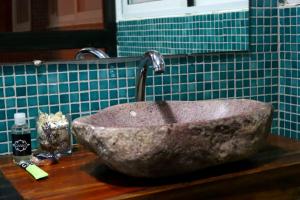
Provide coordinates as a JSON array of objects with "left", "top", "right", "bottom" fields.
[{"left": 279, "top": 7, "right": 300, "bottom": 140}]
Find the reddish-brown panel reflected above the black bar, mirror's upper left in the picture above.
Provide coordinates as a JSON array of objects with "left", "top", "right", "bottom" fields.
[{"left": 8, "top": 0, "right": 103, "bottom": 32}]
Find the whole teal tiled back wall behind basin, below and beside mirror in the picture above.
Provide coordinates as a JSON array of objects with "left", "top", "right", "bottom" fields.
[{"left": 0, "top": 0, "right": 278, "bottom": 154}]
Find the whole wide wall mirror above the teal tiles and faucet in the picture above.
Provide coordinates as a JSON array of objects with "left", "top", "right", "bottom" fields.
[{"left": 0, "top": 0, "right": 249, "bottom": 63}]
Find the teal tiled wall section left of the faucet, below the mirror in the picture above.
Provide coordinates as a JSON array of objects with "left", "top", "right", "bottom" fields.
[{"left": 0, "top": 62, "right": 135, "bottom": 154}]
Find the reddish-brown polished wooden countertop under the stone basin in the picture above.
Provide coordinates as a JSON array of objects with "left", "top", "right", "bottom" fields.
[{"left": 0, "top": 136, "right": 300, "bottom": 200}]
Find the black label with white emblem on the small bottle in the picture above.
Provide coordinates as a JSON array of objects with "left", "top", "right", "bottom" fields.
[{"left": 12, "top": 134, "right": 31, "bottom": 156}]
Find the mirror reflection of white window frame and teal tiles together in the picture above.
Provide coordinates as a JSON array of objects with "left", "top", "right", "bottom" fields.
[{"left": 116, "top": 0, "right": 249, "bottom": 56}]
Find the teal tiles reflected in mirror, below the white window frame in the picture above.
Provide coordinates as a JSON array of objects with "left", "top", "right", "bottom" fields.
[{"left": 117, "top": 11, "right": 249, "bottom": 56}]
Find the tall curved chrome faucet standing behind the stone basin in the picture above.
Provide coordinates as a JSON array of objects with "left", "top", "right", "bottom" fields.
[{"left": 136, "top": 50, "right": 165, "bottom": 101}]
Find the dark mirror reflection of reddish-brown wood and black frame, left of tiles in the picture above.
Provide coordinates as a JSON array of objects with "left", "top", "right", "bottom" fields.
[{"left": 0, "top": 0, "right": 115, "bottom": 63}]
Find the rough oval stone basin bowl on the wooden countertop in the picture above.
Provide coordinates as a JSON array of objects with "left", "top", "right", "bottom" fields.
[{"left": 72, "top": 100, "right": 272, "bottom": 177}]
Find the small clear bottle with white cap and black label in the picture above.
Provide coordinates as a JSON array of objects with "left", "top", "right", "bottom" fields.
[{"left": 11, "top": 113, "right": 31, "bottom": 163}]
